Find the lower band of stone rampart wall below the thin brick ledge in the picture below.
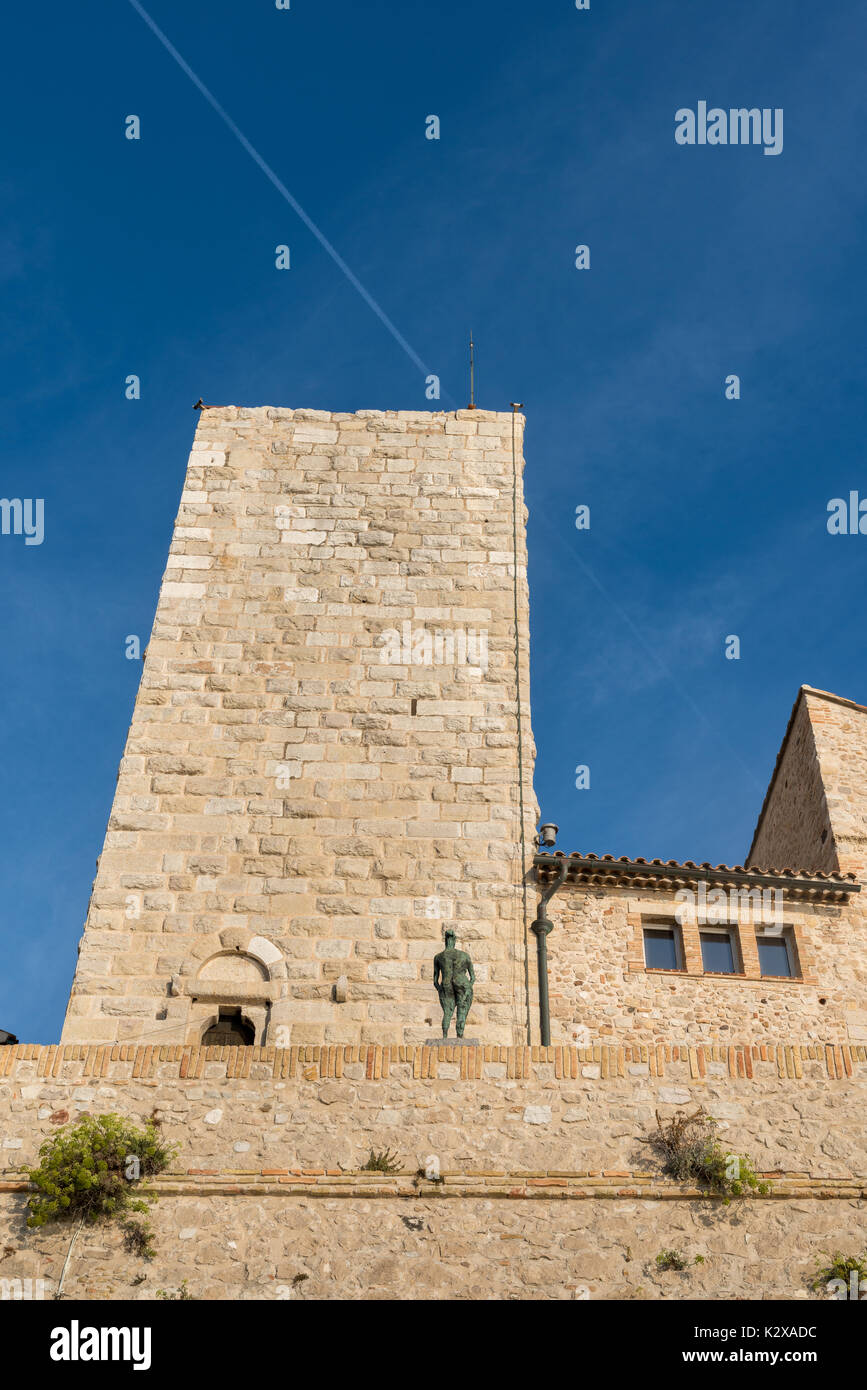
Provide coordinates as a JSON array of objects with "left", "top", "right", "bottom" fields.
[{"left": 0, "top": 1188, "right": 867, "bottom": 1302}]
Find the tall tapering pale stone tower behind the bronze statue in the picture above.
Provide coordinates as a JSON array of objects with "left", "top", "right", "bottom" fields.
[{"left": 63, "top": 406, "right": 536, "bottom": 1045}]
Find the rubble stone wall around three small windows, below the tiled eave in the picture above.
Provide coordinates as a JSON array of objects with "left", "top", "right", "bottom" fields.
[{"left": 547, "top": 887, "right": 867, "bottom": 1043}]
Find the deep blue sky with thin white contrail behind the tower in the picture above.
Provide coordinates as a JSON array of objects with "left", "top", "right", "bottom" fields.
[{"left": 0, "top": 0, "right": 867, "bottom": 1041}]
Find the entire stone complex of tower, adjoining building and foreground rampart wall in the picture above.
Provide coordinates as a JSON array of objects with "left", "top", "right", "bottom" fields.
[{"left": 0, "top": 407, "right": 867, "bottom": 1298}]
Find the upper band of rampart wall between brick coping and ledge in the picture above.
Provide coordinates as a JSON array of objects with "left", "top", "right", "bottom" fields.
[{"left": 0, "top": 1044, "right": 867, "bottom": 1184}]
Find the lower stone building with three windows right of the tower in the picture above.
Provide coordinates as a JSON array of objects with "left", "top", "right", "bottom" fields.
[{"left": 536, "top": 685, "right": 867, "bottom": 1044}]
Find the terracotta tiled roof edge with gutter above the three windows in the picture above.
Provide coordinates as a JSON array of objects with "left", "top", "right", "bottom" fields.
[{"left": 534, "top": 849, "right": 860, "bottom": 894}]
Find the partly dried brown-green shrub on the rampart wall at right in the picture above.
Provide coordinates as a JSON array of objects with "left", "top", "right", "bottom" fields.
[{"left": 643, "top": 1108, "right": 771, "bottom": 1204}]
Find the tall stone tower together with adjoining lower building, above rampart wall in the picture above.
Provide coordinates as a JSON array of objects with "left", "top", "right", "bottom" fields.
[{"left": 63, "top": 407, "right": 867, "bottom": 1045}]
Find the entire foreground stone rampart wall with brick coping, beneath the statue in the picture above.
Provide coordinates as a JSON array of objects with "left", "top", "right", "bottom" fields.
[{"left": 0, "top": 1044, "right": 867, "bottom": 1300}]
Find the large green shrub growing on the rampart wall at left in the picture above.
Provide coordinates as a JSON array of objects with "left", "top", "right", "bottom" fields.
[{"left": 28, "top": 1115, "right": 175, "bottom": 1226}]
